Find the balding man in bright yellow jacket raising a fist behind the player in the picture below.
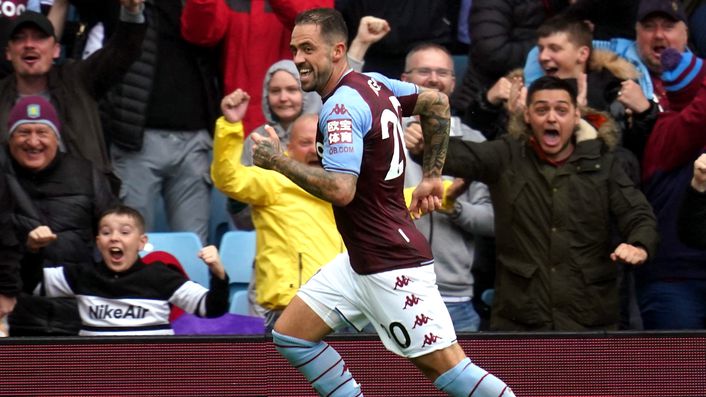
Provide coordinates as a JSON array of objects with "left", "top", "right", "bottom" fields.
[{"left": 211, "top": 89, "right": 345, "bottom": 330}]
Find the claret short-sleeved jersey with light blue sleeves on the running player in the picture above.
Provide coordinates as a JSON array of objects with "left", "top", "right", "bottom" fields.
[{"left": 317, "top": 71, "right": 433, "bottom": 274}]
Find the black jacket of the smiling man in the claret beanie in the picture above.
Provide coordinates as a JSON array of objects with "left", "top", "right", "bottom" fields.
[{"left": 0, "top": 149, "right": 117, "bottom": 336}]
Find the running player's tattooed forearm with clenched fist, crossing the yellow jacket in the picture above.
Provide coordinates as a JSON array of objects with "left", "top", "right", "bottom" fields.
[{"left": 253, "top": 127, "right": 358, "bottom": 206}]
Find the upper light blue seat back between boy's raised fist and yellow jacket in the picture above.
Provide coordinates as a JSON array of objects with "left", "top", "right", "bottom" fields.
[{"left": 220, "top": 230, "right": 255, "bottom": 289}]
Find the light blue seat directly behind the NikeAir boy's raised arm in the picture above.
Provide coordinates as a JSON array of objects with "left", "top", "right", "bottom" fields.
[{"left": 140, "top": 232, "right": 210, "bottom": 288}]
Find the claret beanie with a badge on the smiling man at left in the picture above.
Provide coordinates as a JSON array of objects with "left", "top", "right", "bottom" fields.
[{"left": 7, "top": 95, "right": 64, "bottom": 152}]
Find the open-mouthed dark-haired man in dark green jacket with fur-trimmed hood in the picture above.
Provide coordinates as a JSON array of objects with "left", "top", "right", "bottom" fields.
[{"left": 444, "top": 77, "right": 658, "bottom": 331}]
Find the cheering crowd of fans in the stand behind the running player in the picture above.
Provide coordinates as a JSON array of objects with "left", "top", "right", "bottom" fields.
[{"left": 0, "top": 0, "right": 706, "bottom": 336}]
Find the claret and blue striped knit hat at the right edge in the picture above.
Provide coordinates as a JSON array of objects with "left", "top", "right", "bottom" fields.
[{"left": 660, "top": 48, "right": 706, "bottom": 111}]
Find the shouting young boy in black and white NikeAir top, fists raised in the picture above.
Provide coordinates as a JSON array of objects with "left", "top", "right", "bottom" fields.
[{"left": 30, "top": 205, "right": 229, "bottom": 336}]
